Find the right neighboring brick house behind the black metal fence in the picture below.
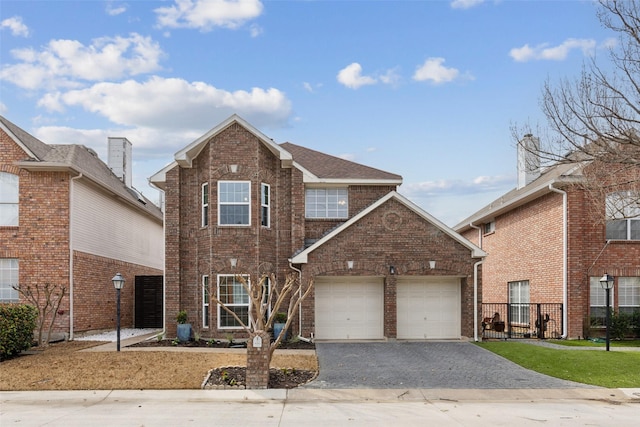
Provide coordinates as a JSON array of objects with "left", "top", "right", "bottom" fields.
[{"left": 454, "top": 136, "right": 640, "bottom": 338}]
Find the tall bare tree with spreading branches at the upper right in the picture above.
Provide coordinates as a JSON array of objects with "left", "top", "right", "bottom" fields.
[{"left": 512, "top": 0, "right": 640, "bottom": 221}]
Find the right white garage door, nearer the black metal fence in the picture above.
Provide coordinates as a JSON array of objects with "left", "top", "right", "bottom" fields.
[{"left": 397, "top": 277, "right": 460, "bottom": 339}]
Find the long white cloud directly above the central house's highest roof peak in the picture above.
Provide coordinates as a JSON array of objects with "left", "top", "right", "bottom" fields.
[{"left": 39, "top": 76, "right": 292, "bottom": 132}]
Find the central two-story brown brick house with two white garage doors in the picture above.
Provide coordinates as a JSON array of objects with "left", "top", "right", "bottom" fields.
[{"left": 151, "top": 115, "right": 485, "bottom": 340}]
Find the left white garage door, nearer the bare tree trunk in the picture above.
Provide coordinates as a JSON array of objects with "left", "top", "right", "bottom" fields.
[{"left": 315, "top": 277, "right": 384, "bottom": 340}]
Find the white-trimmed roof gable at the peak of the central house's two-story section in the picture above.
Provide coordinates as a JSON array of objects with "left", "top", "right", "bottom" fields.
[{"left": 174, "top": 114, "right": 292, "bottom": 168}]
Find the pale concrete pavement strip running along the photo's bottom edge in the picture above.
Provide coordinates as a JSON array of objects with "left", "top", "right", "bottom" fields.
[{"left": 0, "top": 389, "right": 640, "bottom": 427}]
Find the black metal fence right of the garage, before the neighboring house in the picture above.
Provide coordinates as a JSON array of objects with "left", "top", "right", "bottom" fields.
[{"left": 482, "top": 303, "right": 563, "bottom": 339}]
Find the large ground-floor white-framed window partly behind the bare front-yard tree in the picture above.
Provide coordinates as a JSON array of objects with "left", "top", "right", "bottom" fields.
[{"left": 218, "top": 274, "right": 249, "bottom": 329}]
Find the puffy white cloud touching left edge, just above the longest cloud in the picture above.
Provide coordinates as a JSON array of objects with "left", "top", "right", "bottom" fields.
[{"left": 0, "top": 33, "right": 163, "bottom": 89}]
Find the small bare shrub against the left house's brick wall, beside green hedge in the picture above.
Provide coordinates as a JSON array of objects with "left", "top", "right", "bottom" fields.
[{"left": 14, "top": 283, "right": 67, "bottom": 346}]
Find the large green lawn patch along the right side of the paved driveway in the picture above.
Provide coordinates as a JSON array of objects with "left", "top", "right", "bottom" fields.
[{"left": 477, "top": 341, "right": 640, "bottom": 388}]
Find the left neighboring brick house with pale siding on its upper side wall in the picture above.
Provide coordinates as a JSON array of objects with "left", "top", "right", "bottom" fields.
[{"left": 0, "top": 116, "right": 164, "bottom": 339}]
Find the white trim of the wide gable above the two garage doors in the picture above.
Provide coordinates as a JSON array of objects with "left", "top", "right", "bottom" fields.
[{"left": 290, "top": 191, "right": 487, "bottom": 264}]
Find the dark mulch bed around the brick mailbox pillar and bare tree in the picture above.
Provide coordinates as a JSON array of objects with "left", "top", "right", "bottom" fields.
[{"left": 202, "top": 366, "right": 317, "bottom": 389}]
